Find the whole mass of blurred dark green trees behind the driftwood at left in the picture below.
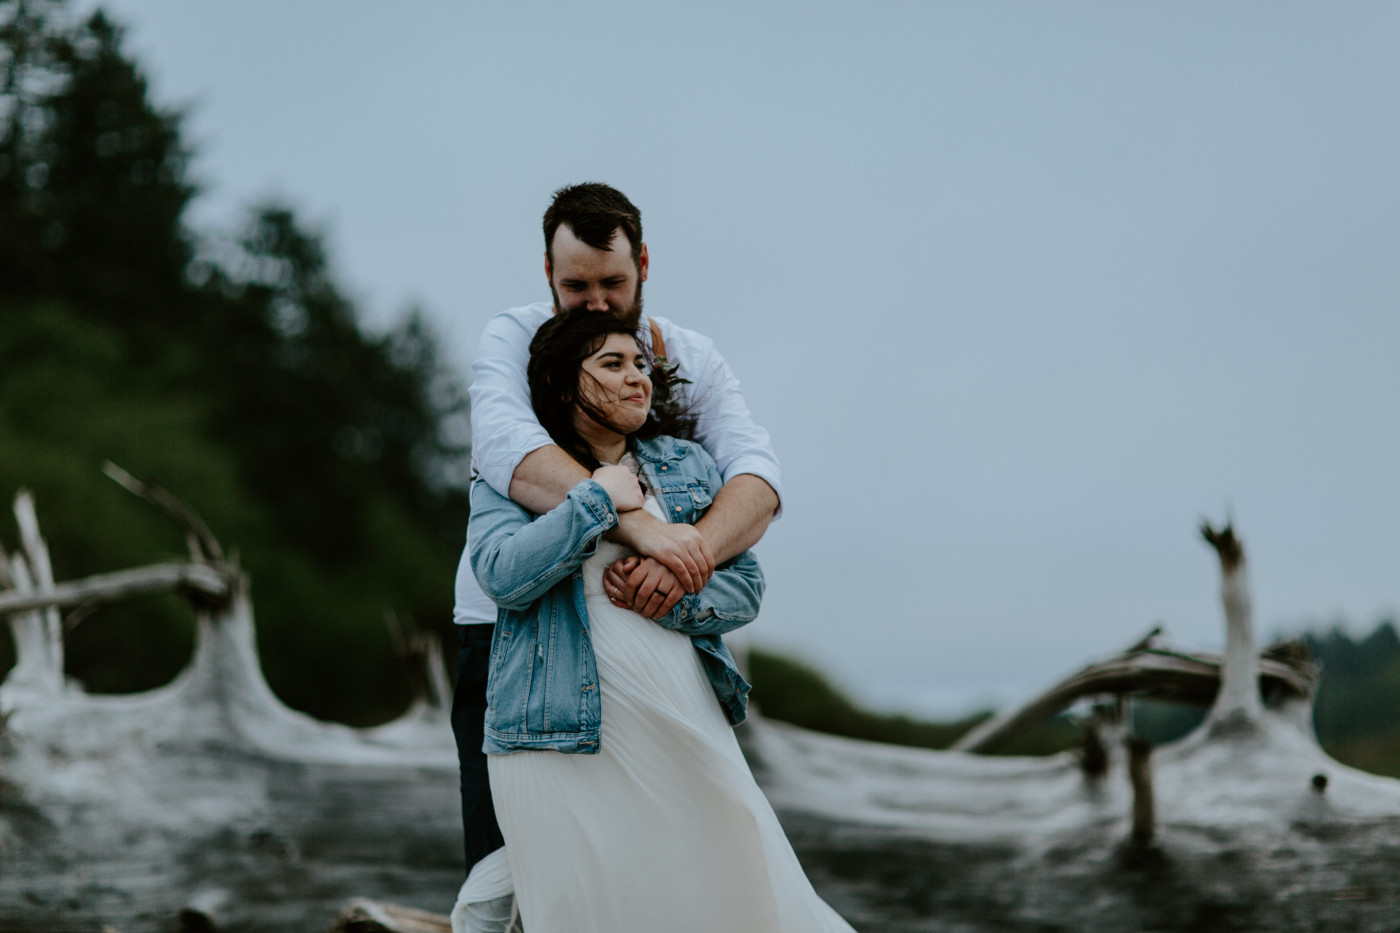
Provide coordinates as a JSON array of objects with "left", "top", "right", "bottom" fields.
[{"left": 0, "top": 0, "right": 466, "bottom": 723}]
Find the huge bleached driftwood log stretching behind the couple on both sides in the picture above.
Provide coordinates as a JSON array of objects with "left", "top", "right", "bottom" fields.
[{"left": 0, "top": 481, "right": 1400, "bottom": 933}]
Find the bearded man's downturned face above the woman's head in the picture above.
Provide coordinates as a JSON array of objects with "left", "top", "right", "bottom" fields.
[{"left": 545, "top": 224, "right": 647, "bottom": 326}]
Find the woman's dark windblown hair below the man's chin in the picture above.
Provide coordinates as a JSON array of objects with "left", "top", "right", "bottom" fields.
[{"left": 525, "top": 308, "right": 694, "bottom": 469}]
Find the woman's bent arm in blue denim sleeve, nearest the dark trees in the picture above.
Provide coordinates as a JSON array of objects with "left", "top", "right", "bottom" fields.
[{"left": 466, "top": 479, "right": 617, "bottom": 609}]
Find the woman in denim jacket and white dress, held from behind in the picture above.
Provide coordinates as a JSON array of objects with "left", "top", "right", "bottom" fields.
[{"left": 468, "top": 311, "right": 850, "bottom": 933}]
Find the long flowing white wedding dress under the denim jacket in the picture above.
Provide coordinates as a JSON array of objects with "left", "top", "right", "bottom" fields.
[{"left": 489, "top": 497, "right": 851, "bottom": 933}]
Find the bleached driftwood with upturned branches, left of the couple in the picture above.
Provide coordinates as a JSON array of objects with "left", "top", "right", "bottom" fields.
[{"left": 0, "top": 468, "right": 462, "bottom": 933}]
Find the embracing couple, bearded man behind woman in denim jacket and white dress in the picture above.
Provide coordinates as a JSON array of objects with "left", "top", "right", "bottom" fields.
[{"left": 452, "top": 184, "right": 850, "bottom": 933}]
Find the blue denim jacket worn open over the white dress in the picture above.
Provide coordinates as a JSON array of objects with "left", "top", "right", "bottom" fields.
[{"left": 468, "top": 437, "right": 763, "bottom": 755}]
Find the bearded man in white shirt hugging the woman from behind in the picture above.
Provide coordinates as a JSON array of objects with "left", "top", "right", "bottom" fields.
[{"left": 452, "top": 184, "right": 781, "bottom": 924}]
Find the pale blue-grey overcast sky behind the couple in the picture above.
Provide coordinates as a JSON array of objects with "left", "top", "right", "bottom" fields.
[{"left": 85, "top": 0, "right": 1400, "bottom": 713}]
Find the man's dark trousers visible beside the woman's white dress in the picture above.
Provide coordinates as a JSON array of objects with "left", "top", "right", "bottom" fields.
[{"left": 452, "top": 625, "right": 505, "bottom": 871}]
